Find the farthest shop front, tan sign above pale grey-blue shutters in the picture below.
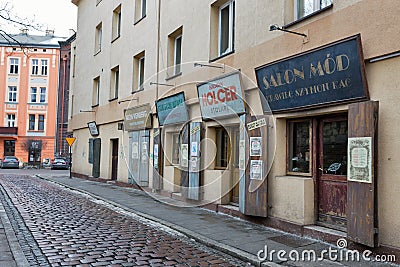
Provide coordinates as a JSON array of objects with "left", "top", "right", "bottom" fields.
[{"left": 124, "top": 104, "right": 152, "bottom": 187}]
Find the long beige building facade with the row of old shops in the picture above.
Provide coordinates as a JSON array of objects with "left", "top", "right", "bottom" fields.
[{"left": 69, "top": 0, "right": 400, "bottom": 253}]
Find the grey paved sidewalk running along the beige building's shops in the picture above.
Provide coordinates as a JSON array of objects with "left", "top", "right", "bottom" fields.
[{"left": 40, "top": 175, "right": 387, "bottom": 266}]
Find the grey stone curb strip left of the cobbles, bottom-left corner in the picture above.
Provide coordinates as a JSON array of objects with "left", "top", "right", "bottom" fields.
[{"left": 0, "top": 185, "right": 30, "bottom": 267}]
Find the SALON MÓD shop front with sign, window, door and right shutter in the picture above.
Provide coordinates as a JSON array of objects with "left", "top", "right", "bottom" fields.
[{"left": 256, "top": 35, "right": 378, "bottom": 247}]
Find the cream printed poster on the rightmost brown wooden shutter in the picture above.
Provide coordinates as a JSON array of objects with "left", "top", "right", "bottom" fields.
[{"left": 347, "top": 137, "right": 372, "bottom": 183}]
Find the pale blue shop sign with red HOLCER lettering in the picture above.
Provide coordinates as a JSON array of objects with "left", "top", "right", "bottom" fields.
[{"left": 197, "top": 72, "right": 245, "bottom": 120}]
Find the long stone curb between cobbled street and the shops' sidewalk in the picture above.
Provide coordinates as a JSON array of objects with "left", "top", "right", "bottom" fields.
[{"left": 36, "top": 175, "right": 268, "bottom": 266}]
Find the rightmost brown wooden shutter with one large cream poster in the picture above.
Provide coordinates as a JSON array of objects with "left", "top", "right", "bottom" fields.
[{"left": 347, "top": 101, "right": 379, "bottom": 247}]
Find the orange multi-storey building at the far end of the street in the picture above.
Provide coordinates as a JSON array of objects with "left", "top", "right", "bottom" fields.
[{"left": 0, "top": 31, "right": 64, "bottom": 165}]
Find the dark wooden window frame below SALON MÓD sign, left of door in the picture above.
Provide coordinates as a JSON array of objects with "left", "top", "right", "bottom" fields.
[{"left": 286, "top": 118, "right": 314, "bottom": 177}]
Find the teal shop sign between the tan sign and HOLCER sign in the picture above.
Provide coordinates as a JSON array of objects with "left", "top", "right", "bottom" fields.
[{"left": 156, "top": 92, "right": 189, "bottom": 126}]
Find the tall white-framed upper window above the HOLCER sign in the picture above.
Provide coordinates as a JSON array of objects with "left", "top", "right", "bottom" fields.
[{"left": 218, "top": 1, "right": 235, "bottom": 56}]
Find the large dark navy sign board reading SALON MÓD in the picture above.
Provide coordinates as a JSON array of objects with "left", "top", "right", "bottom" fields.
[{"left": 256, "top": 35, "right": 368, "bottom": 112}]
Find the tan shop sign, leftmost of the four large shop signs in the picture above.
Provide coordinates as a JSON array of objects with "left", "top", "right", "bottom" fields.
[{"left": 124, "top": 104, "right": 151, "bottom": 131}]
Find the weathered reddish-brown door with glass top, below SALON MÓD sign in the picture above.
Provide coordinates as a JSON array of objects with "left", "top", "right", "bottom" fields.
[{"left": 318, "top": 116, "right": 347, "bottom": 230}]
